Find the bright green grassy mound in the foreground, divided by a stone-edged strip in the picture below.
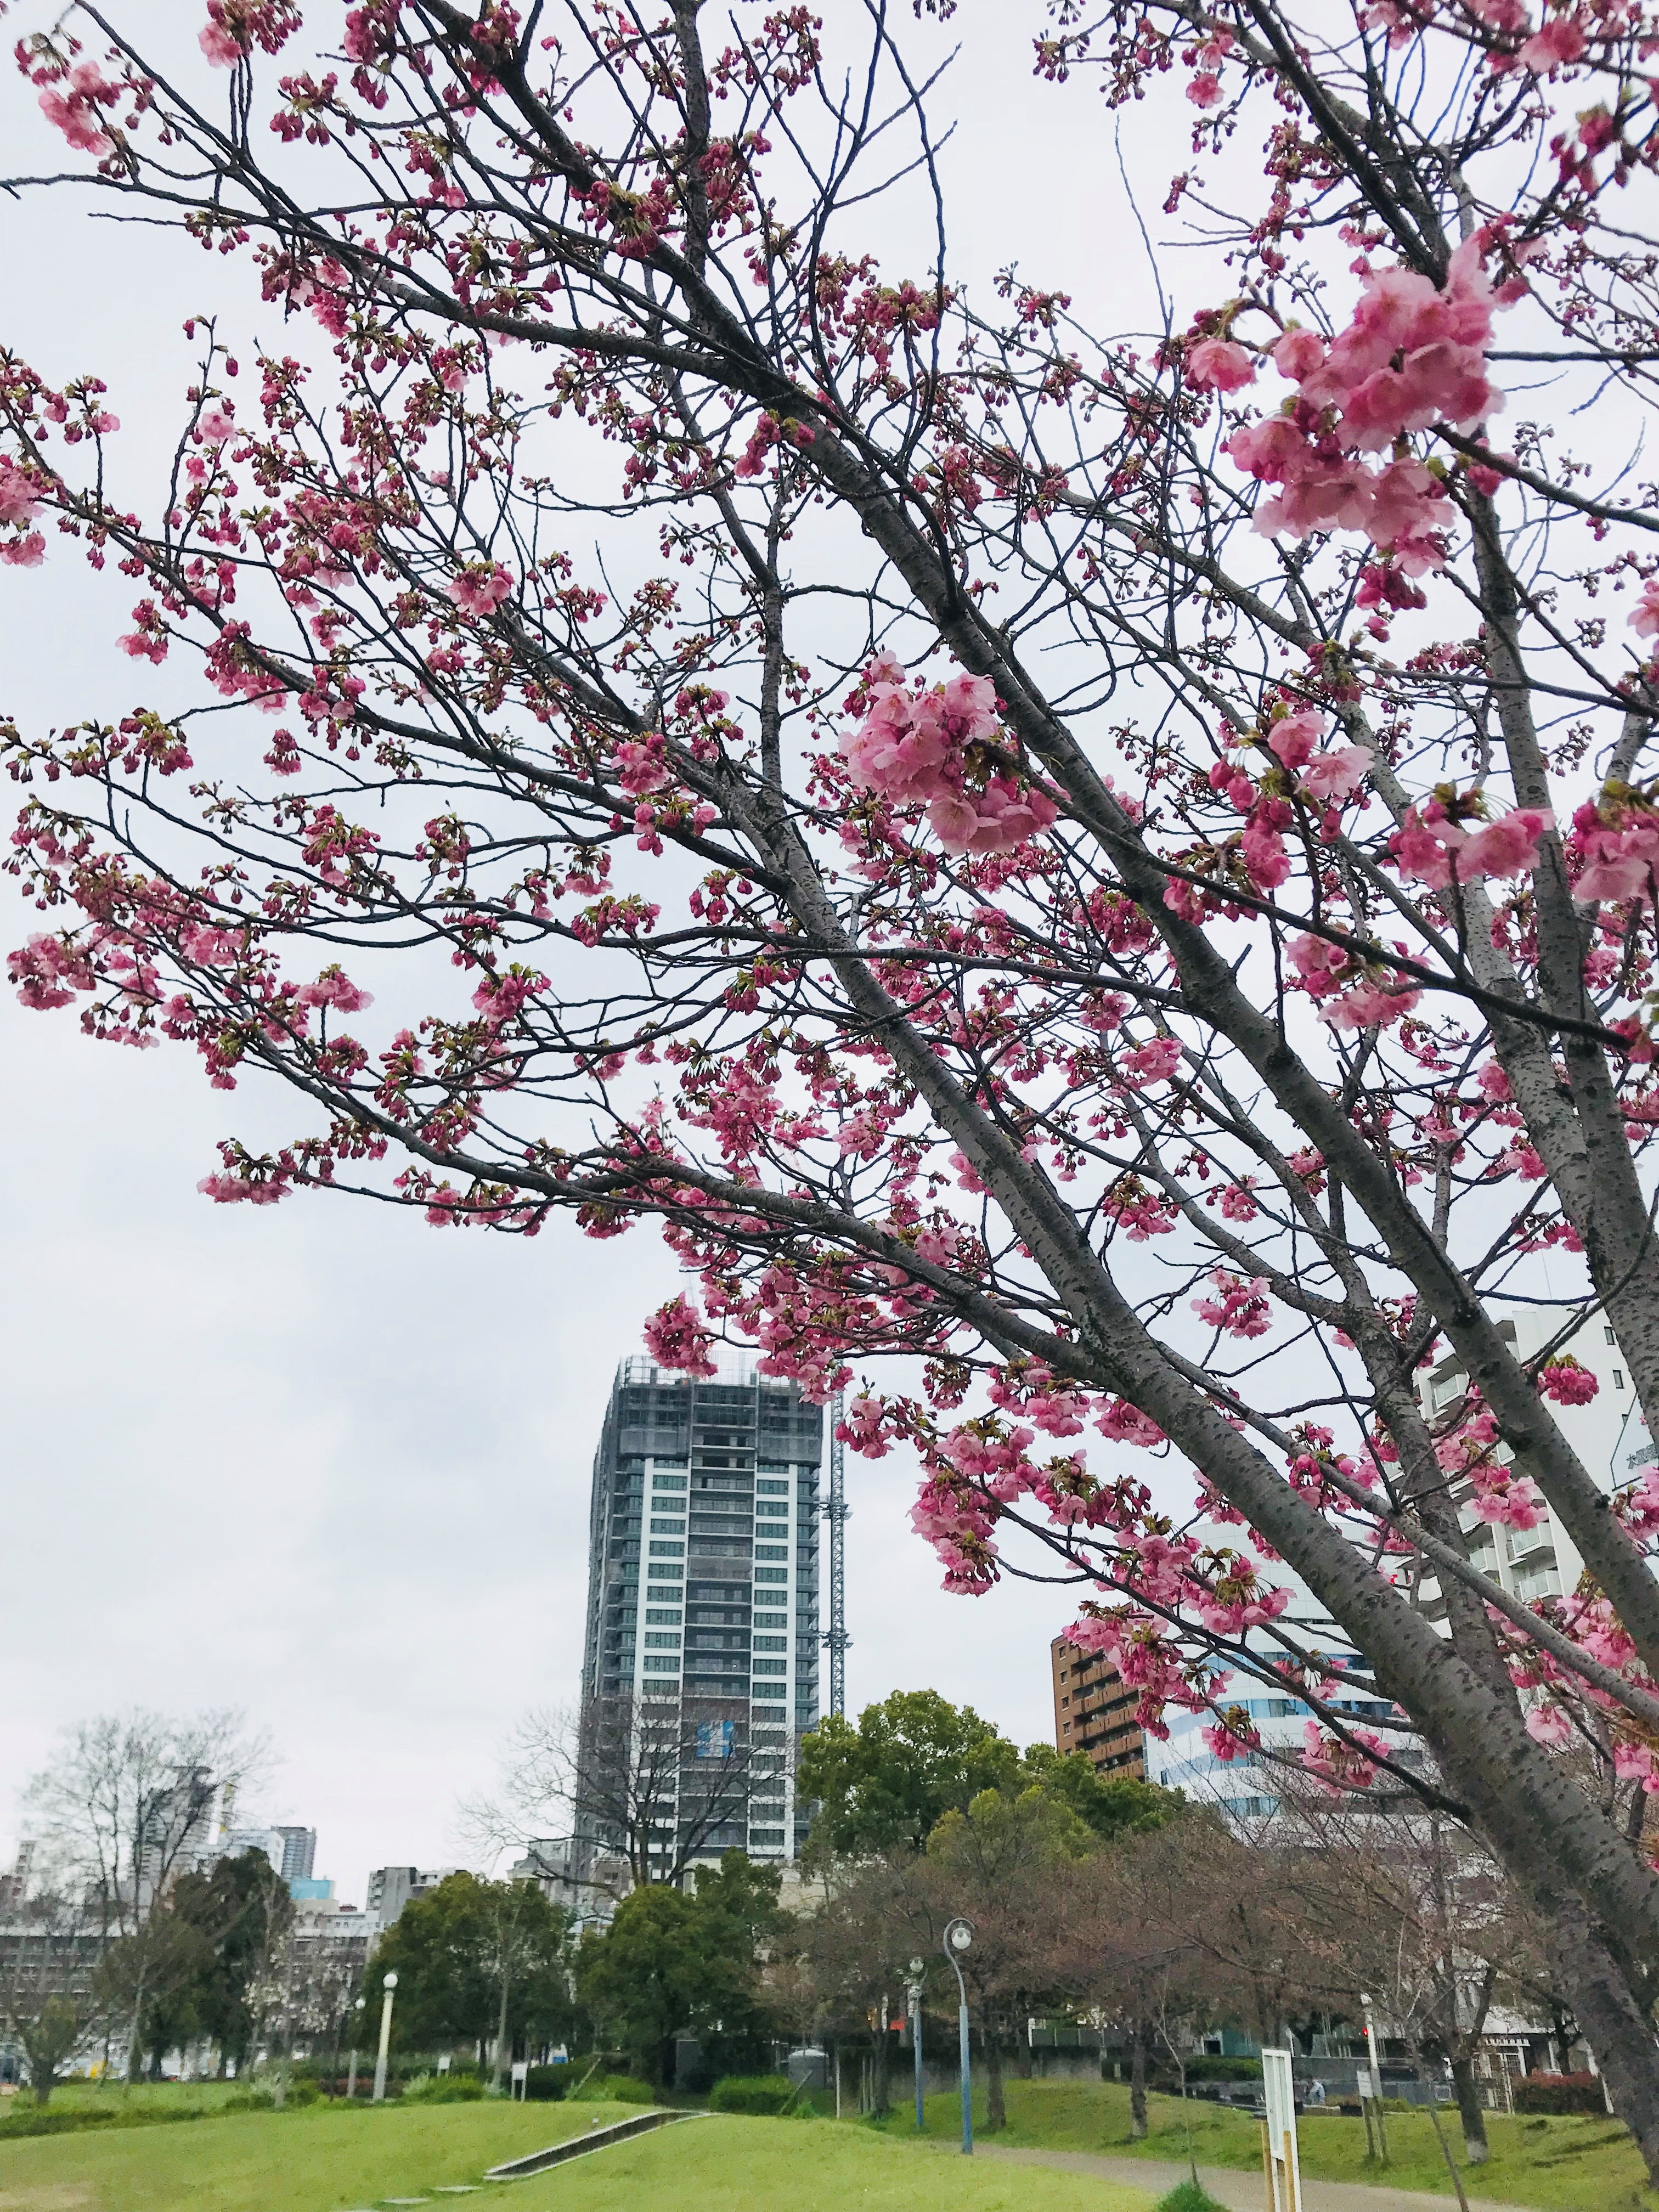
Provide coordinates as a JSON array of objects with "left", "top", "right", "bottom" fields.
[{"left": 0, "top": 2101, "right": 1153, "bottom": 2212}]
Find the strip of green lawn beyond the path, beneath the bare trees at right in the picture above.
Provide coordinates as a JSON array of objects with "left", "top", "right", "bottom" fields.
[{"left": 885, "top": 2081, "right": 1659, "bottom": 2212}]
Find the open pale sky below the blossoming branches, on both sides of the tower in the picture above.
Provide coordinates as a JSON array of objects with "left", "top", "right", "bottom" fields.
[{"left": 0, "top": 993, "right": 1077, "bottom": 1905}]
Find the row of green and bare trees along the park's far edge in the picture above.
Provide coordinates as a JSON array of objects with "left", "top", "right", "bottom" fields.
[{"left": 0, "top": 1690, "right": 1579, "bottom": 2163}]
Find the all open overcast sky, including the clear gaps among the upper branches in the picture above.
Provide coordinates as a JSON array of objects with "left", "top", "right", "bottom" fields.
[{"left": 0, "top": 0, "right": 1179, "bottom": 1900}]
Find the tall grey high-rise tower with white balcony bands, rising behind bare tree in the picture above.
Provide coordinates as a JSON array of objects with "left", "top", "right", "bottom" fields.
[{"left": 582, "top": 1358, "right": 823, "bottom": 1858}]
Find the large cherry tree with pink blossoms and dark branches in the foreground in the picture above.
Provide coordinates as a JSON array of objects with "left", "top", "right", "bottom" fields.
[{"left": 0, "top": 0, "right": 1659, "bottom": 2172}]
